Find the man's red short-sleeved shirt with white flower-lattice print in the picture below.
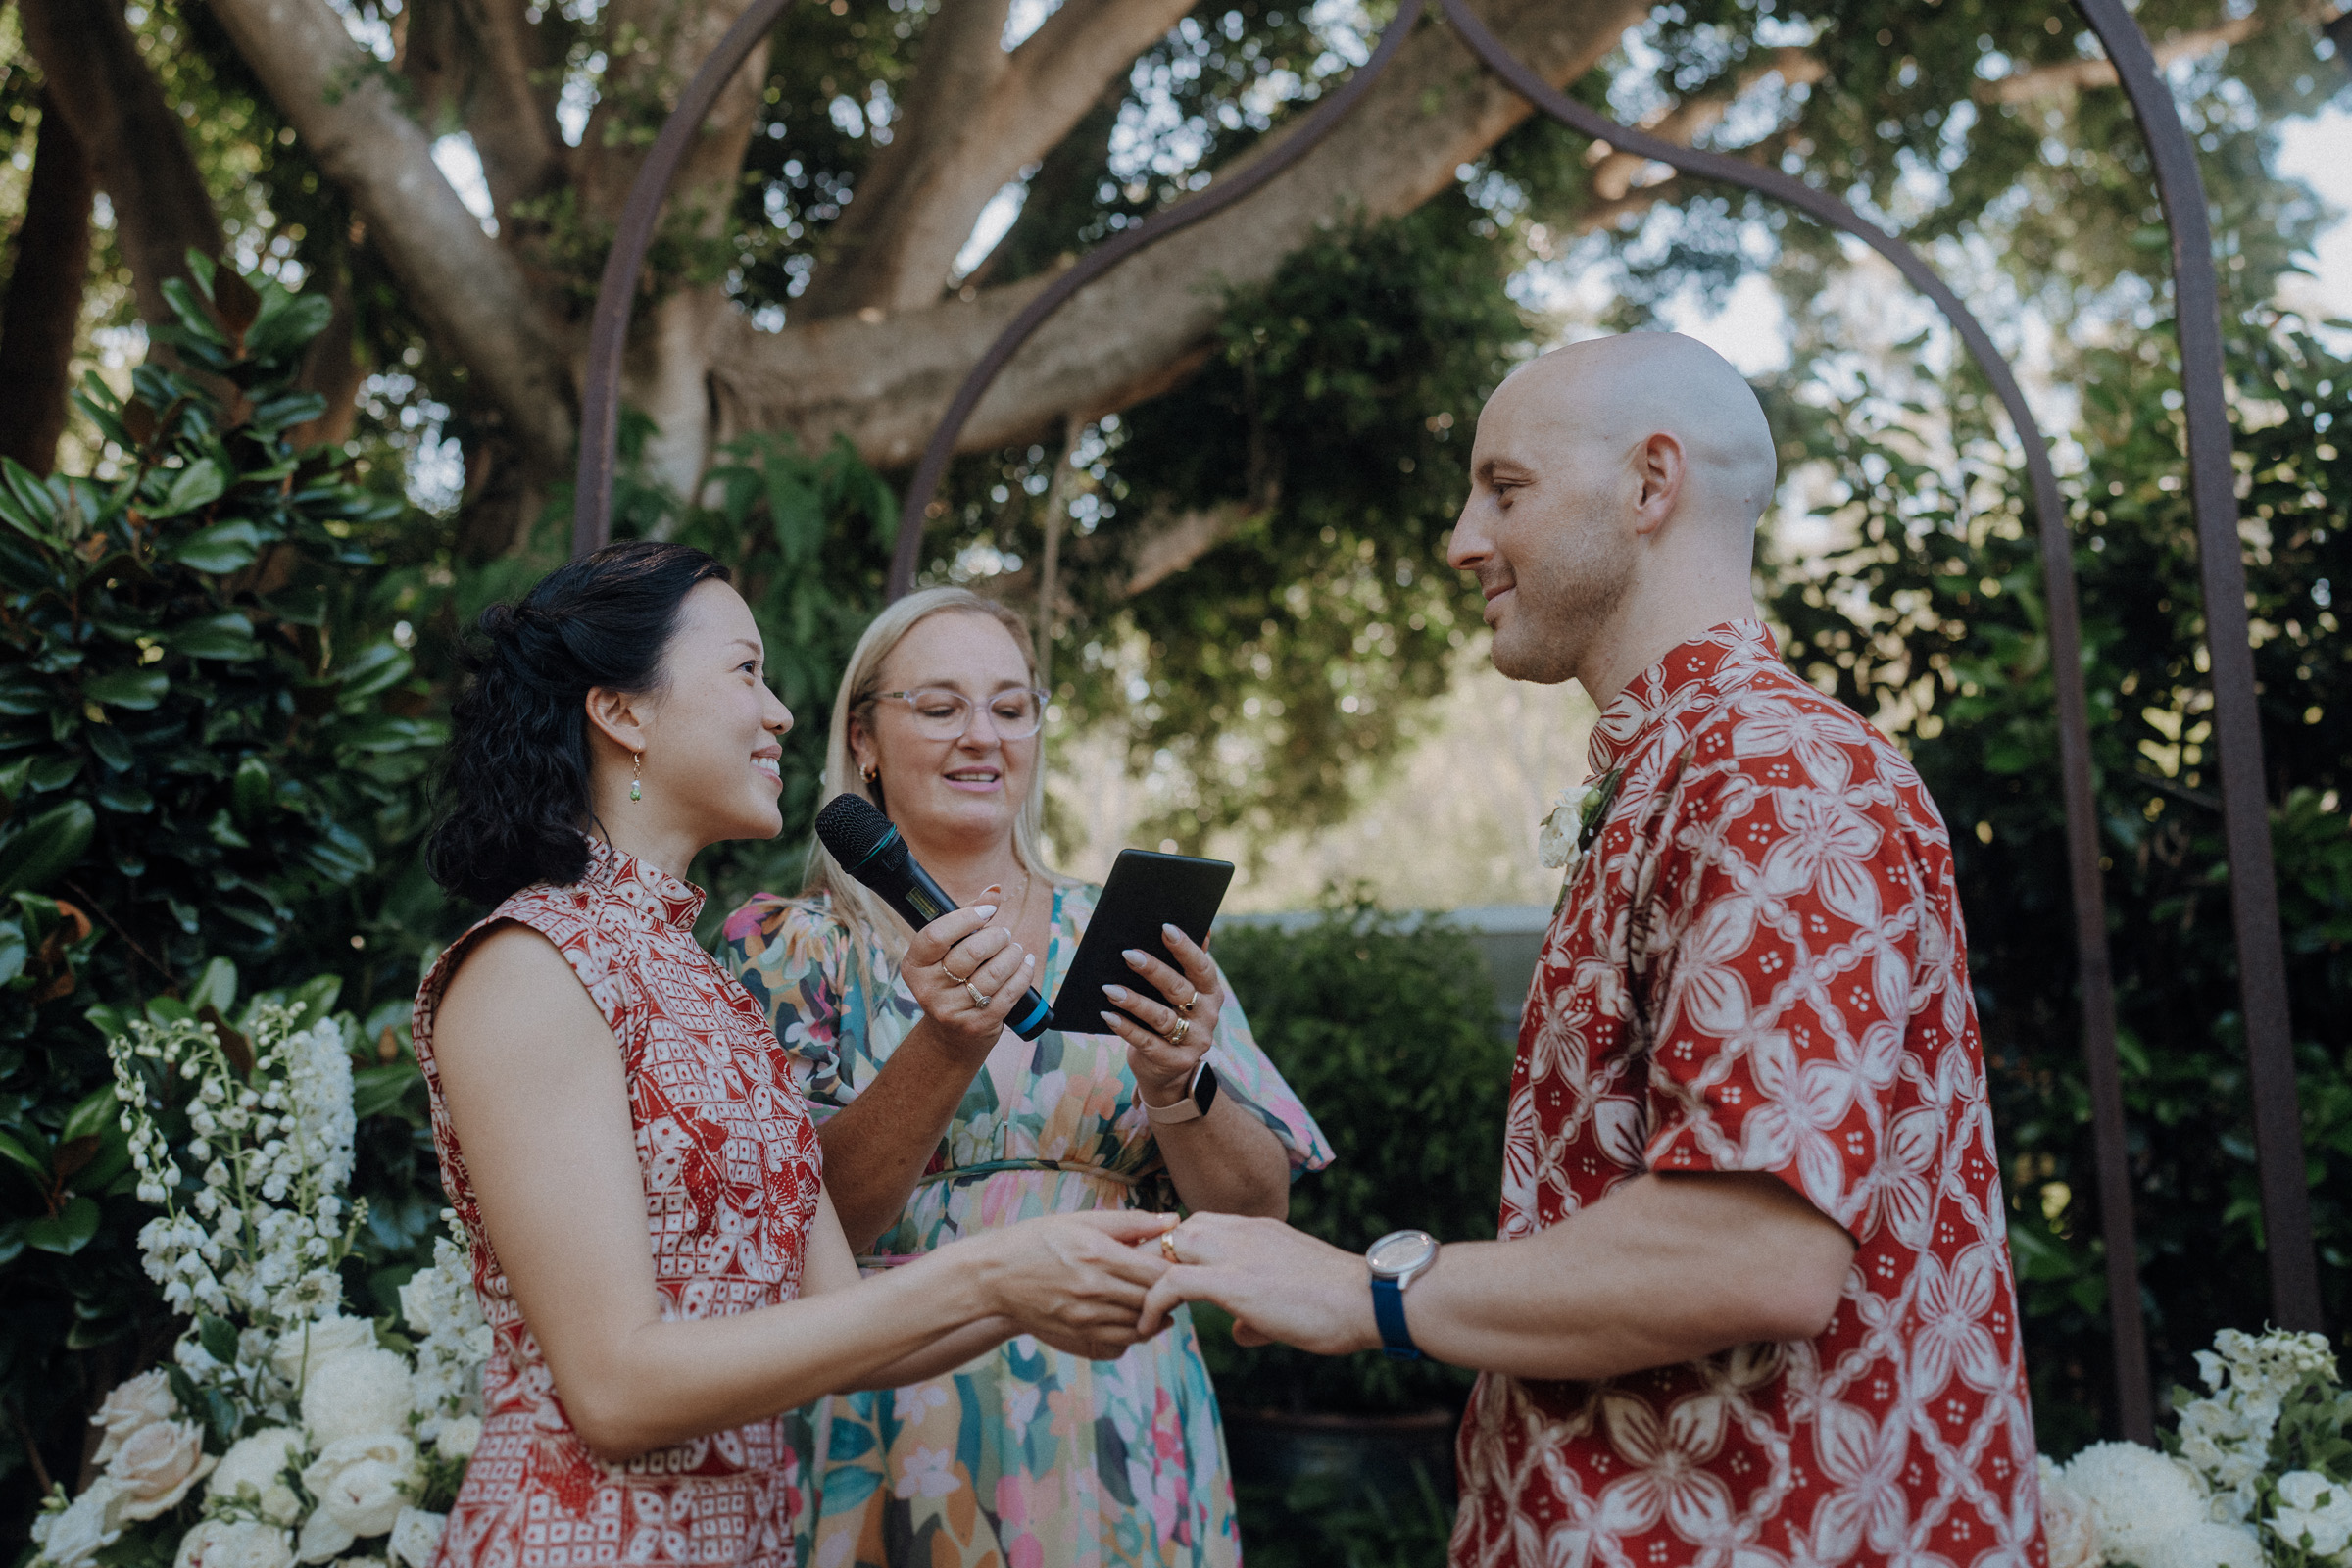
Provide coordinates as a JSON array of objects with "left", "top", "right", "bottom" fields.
[{"left": 1453, "top": 620, "right": 2046, "bottom": 1568}]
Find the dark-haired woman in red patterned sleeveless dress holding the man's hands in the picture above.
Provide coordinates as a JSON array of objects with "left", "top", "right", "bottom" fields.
[{"left": 416, "top": 543, "right": 1174, "bottom": 1568}]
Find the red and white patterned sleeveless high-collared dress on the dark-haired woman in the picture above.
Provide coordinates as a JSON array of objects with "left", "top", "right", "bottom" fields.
[{"left": 416, "top": 844, "right": 818, "bottom": 1568}]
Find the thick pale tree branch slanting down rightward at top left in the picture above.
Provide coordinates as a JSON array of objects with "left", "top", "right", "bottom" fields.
[{"left": 212, "top": 0, "right": 574, "bottom": 466}]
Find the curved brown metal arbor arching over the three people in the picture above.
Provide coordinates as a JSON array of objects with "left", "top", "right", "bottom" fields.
[{"left": 571, "top": 0, "right": 2322, "bottom": 1441}]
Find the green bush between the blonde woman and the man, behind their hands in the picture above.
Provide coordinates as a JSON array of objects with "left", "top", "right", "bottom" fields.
[{"left": 1195, "top": 896, "right": 1512, "bottom": 1413}]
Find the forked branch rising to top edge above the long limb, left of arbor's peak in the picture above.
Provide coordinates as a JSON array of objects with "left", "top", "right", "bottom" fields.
[{"left": 800, "top": 0, "right": 1190, "bottom": 315}]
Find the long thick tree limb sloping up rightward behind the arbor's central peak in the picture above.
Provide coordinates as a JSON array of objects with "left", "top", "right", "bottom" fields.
[{"left": 712, "top": 0, "right": 1644, "bottom": 466}]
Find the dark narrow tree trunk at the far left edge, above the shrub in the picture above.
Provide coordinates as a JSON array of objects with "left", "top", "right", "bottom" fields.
[{"left": 0, "top": 89, "right": 99, "bottom": 475}]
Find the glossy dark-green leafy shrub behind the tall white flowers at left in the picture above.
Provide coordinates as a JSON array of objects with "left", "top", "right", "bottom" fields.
[{"left": 0, "top": 266, "right": 442, "bottom": 1511}]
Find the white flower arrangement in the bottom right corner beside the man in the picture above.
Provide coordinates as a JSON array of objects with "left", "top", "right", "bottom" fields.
[{"left": 2041, "top": 1328, "right": 2352, "bottom": 1568}]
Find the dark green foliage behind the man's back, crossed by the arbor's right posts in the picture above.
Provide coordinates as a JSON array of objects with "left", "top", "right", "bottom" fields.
[{"left": 1771, "top": 310, "right": 2352, "bottom": 1452}]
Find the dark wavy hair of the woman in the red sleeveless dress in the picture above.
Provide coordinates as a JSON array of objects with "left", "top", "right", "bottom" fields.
[{"left": 425, "top": 538, "right": 727, "bottom": 906}]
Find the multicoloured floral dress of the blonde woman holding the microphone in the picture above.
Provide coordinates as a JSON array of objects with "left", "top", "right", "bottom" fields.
[{"left": 722, "top": 886, "right": 1331, "bottom": 1568}]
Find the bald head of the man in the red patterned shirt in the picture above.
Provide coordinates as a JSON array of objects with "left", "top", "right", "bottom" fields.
[{"left": 1448, "top": 331, "right": 1776, "bottom": 682}]
